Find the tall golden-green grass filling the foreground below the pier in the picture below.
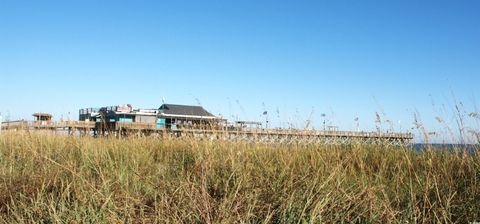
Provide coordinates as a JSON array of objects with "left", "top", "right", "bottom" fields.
[{"left": 0, "top": 132, "right": 480, "bottom": 223}]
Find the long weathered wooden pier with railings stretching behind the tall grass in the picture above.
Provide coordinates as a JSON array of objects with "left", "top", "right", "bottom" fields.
[{"left": 2, "top": 120, "right": 414, "bottom": 145}]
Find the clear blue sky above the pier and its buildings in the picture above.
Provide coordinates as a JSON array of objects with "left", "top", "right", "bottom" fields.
[{"left": 0, "top": 0, "right": 480, "bottom": 142}]
